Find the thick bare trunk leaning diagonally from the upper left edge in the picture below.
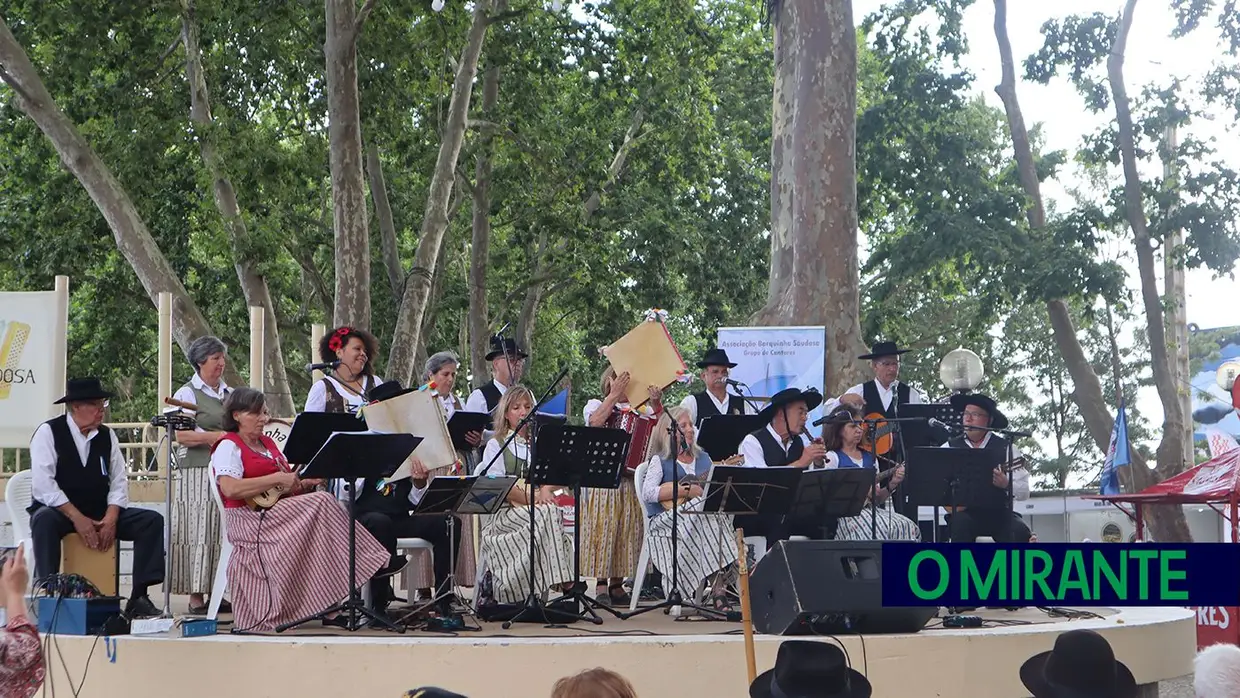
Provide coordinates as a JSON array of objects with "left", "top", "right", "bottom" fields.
[{"left": 0, "top": 17, "right": 242, "bottom": 386}]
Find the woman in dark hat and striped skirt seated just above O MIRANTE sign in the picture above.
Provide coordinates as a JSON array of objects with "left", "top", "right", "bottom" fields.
[{"left": 822, "top": 404, "right": 921, "bottom": 541}]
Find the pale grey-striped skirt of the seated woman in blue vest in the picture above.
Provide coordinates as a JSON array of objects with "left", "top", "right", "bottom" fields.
[{"left": 646, "top": 497, "right": 737, "bottom": 599}]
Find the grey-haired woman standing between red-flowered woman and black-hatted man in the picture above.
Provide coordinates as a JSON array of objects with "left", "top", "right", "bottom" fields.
[{"left": 405, "top": 351, "right": 482, "bottom": 595}]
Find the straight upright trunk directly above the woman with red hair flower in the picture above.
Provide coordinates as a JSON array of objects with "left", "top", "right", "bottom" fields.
[{"left": 324, "top": 0, "right": 371, "bottom": 327}]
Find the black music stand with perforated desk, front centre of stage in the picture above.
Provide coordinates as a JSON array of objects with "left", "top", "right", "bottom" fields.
[{"left": 529, "top": 424, "right": 630, "bottom": 625}]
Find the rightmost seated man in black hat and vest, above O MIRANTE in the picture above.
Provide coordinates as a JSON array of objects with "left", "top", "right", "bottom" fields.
[{"left": 944, "top": 393, "right": 1032, "bottom": 543}]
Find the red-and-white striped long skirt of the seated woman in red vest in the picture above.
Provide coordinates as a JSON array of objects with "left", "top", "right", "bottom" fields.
[{"left": 224, "top": 492, "right": 388, "bottom": 631}]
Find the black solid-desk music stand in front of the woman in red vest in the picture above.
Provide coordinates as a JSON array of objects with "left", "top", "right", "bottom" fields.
[{"left": 275, "top": 431, "right": 422, "bottom": 632}]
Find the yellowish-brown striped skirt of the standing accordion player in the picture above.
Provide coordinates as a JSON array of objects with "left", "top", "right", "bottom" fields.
[{"left": 578, "top": 477, "right": 646, "bottom": 580}]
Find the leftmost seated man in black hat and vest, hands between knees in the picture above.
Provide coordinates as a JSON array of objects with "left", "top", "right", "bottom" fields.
[{"left": 29, "top": 378, "right": 164, "bottom": 619}]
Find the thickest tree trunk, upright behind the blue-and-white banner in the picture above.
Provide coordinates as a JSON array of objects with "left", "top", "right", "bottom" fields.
[{"left": 753, "top": 1, "right": 864, "bottom": 394}]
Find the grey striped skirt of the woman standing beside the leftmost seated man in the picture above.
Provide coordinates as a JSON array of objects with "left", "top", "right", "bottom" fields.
[{"left": 171, "top": 467, "right": 219, "bottom": 594}]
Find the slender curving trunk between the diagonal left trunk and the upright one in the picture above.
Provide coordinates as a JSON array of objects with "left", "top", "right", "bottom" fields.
[{"left": 181, "top": 0, "right": 294, "bottom": 414}]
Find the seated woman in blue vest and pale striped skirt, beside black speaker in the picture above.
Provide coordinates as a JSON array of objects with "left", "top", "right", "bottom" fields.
[{"left": 636, "top": 407, "right": 737, "bottom": 610}]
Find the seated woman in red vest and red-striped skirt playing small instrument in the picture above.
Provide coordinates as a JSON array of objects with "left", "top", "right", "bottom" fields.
[{"left": 211, "top": 388, "right": 388, "bottom": 631}]
